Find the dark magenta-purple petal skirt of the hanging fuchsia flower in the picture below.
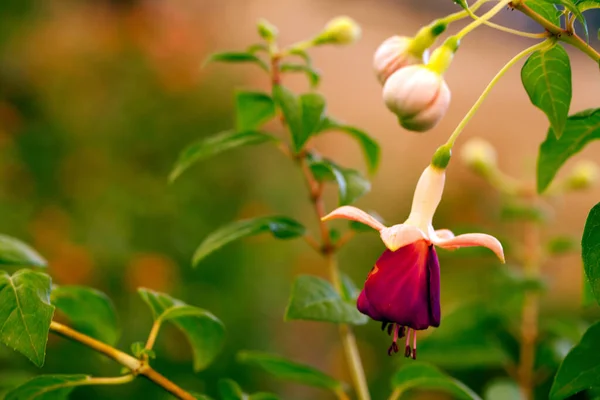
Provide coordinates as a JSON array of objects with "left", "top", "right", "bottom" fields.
[{"left": 357, "top": 241, "right": 440, "bottom": 329}]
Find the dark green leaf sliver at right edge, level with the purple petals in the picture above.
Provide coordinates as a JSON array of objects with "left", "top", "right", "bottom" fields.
[{"left": 581, "top": 203, "right": 600, "bottom": 304}]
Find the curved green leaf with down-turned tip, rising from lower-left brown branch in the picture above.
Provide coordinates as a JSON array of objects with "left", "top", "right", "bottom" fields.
[{"left": 138, "top": 288, "right": 225, "bottom": 371}]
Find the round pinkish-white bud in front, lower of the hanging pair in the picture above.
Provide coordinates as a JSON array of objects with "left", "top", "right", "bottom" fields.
[{"left": 383, "top": 65, "right": 450, "bottom": 132}]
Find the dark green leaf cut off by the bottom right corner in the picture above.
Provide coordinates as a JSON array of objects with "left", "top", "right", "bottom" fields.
[{"left": 550, "top": 322, "right": 600, "bottom": 400}]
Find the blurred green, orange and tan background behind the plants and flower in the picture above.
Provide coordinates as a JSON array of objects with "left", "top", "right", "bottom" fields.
[{"left": 0, "top": 0, "right": 600, "bottom": 399}]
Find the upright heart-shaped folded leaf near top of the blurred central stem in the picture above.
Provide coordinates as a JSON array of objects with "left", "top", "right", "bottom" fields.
[{"left": 273, "top": 85, "right": 326, "bottom": 152}]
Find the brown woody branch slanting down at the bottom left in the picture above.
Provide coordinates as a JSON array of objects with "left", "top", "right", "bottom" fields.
[{"left": 50, "top": 321, "right": 195, "bottom": 400}]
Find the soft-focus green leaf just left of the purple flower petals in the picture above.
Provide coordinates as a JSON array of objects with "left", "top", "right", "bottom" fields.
[{"left": 285, "top": 275, "right": 368, "bottom": 325}]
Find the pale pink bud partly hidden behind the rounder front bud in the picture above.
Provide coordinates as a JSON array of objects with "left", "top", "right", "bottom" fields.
[{"left": 373, "top": 36, "right": 429, "bottom": 85}]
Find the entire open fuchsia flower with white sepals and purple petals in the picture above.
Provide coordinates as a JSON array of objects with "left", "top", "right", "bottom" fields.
[{"left": 323, "top": 165, "right": 504, "bottom": 359}]
